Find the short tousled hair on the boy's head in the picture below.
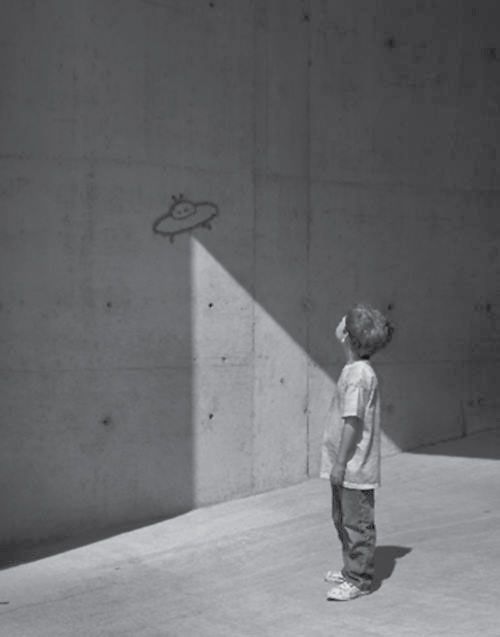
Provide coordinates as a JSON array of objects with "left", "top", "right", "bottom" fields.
[{"left": 345, "top": 303, "right": 394, "bottom": 358}]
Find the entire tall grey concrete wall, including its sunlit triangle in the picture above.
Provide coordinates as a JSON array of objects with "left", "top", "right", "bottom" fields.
[{"left": 0, "top": 0, "right": 500, "bottom": 546}]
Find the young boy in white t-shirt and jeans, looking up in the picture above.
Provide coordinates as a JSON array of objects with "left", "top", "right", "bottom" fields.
[{"left": 321, "top": 305, "right": 393, "bottom": 601}]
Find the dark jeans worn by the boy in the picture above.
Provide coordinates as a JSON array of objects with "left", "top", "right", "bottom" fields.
[{"left": 332, "top": 485, "right": 376, "bottom": 590}]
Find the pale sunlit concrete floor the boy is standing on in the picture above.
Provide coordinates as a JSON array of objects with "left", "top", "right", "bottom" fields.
[{"left": 0, "top": 431, "right": 500, "bottom": 637}]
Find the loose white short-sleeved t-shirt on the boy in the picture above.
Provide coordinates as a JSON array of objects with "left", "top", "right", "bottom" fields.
[{"left": 321, "top": 360, "right": 380, "bottom": 489}]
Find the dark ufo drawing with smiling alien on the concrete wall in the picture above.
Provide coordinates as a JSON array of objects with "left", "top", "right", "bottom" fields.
[{"left": 153, "top": 194, "right": 219, "bottom": 243}]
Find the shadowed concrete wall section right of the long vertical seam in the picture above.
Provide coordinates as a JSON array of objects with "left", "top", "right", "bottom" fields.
[{"left": 304, "top": 1, "right": 500, "bottom": 466}]
